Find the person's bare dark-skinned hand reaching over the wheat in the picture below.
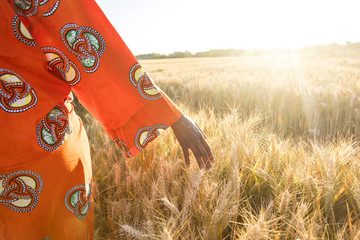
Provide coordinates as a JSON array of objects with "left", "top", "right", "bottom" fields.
[{"left": 171, "top": 115, "right": 214, "bottom": 170}]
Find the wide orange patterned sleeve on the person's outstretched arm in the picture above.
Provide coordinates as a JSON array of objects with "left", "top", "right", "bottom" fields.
[{"left": 8, "top": 0, "right": 181, "bottom": 156}]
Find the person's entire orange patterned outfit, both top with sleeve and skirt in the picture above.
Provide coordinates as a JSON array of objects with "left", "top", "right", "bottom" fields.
[{"left": 0, "top": 0, "right": 181, "bottom": 240}]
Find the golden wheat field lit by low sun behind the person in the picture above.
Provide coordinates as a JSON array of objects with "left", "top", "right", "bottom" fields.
[{"left": 78, "top": 53, "right": 360, "bottom": 240}]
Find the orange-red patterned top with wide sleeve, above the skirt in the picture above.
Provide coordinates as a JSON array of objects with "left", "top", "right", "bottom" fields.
[{"left": 0, "top": 0, "right": 181, "bottom": 168}]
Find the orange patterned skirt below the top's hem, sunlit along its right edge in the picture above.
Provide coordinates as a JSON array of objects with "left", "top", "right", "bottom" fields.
[{"left": 0, "top": 100, "right": 94, "bottom": 240}]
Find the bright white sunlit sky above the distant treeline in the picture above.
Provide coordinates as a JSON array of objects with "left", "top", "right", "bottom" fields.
[{"left": 96, "top": 0, "right": 360, "bottom": 55}]
